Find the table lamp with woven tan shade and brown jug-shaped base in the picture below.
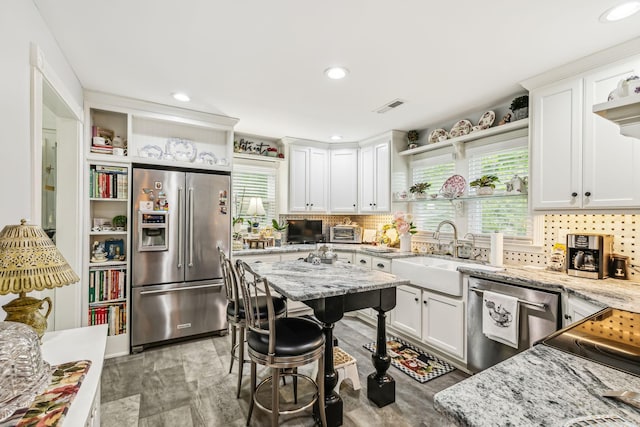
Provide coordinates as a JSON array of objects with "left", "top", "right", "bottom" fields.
[{"left": 0, "top": 219, "right": 80, "bottom": 338}]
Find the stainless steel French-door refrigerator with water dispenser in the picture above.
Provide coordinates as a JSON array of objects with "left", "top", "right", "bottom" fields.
[{"left": 131, "top": 164, "right": 231, "bottom": 352}]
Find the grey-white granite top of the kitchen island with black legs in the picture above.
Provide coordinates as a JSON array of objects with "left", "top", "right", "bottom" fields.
[{"left": 242, "top": 260, "right": 409, "bottom": 301}]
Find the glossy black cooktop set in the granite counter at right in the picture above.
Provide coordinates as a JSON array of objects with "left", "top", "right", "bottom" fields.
[{"left": 542, "top": 308, "right": 640, "bottom": 376}]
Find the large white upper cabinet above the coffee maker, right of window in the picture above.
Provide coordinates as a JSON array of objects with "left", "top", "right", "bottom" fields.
[{"left": 530, "top": 56, "right": 640, "bottom": 210}]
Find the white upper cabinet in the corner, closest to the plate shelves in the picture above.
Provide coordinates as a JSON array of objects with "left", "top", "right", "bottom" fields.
[{"left": 359, "top": 138, "right": 391, "bottom": 213}]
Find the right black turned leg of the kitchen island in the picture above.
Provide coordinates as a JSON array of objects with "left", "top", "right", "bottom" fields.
[{"left": 367, "top": 307, "right": 396, "bottom": 408}]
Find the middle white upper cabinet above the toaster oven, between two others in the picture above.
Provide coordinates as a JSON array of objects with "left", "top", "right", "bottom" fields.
[{"left": 329, "top": 148, "right": 358, "bottom": 213}]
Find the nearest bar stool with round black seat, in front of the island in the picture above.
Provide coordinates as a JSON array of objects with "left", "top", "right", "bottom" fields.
[{"left": 236, "top": 260, "right": 327, "bottom": 427}]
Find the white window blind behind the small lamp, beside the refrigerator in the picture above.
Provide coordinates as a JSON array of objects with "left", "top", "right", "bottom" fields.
[{"left": 231, "top": 166, "right": 276, "bottom": 226}]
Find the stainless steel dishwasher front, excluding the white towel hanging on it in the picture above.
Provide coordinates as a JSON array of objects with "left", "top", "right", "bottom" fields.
[{"left": 467, "top": 277, "right": 560, "bottom": 372}]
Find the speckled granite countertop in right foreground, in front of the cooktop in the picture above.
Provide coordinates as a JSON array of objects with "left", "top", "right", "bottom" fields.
[{"left": 434, "top": 345, "right": 640, "bottom": 426}]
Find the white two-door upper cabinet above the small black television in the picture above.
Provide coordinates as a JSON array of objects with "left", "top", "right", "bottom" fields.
[{"left": 289, "top": 146, "right": 329, "bottom": 212}]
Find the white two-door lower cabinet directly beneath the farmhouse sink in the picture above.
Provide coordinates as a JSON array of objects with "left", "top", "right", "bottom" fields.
[{"left": 391, "top": 285, "right": 466, "bottom": 360}]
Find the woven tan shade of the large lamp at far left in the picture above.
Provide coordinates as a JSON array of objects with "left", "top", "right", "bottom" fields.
[{"left": 0, "top": 219, "right": 80, "bottom": 295}]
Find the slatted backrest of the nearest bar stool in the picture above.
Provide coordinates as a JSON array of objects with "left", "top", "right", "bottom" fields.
[{"left": 236, "top": 260, "right": 276, "bottom": 355}]
